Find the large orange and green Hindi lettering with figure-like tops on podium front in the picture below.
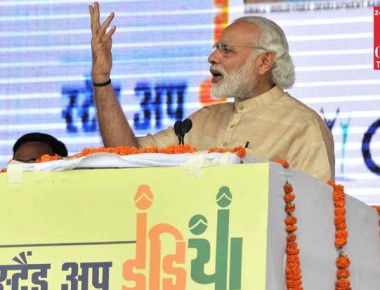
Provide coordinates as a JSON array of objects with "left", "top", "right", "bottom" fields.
[{"left": 122, "top": 184, "right": 243, "bottom": 290}]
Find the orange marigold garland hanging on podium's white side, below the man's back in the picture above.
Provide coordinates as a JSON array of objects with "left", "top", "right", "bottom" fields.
[{"left": 327, "top": 180, "right": 351, "bottom": 290}]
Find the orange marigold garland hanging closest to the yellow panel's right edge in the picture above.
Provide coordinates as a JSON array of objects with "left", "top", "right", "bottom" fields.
[{"left": 276, "top": 160, "right": 303, "bottom": 290}]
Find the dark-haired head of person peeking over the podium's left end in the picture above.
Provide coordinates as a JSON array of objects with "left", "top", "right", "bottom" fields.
[{"left": 13, "top": 132, "right": 68, "bottom": 162}]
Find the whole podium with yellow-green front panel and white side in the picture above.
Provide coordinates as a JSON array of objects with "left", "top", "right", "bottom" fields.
[{"left": 0, "top": 162, "right": 380, "bottom": 290}]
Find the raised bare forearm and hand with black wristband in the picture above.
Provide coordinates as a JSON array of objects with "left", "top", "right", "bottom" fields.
[{"left": 89, "top": 2, "right": 137, "bottom": 147}]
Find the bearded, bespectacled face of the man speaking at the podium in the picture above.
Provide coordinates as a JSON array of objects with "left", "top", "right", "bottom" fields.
[{"left": 209, "top": 22, "right": 259, "bottom": 99}]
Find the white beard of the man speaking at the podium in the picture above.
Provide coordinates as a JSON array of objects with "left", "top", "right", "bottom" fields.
[{"left": 211, "top": 57, "right": 257, "bottom": 100}]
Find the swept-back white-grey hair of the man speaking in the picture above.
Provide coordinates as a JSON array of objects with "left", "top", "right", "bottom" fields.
[{"left": 233, "top": 16, "right": 296, "bottom": 89}]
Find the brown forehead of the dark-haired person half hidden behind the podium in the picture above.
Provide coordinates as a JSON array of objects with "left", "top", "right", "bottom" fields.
[{"left": 13, "top": 141, "right": 54, "bottom": 162}]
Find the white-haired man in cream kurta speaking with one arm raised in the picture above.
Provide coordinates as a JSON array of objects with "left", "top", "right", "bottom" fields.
[{"left": 89, "top": 2, "right": 335, "bottom": 181}]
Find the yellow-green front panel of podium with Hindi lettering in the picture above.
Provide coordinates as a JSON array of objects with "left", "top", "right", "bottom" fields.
[{"left": 0, "top": 163, "right": 269, "bottom": 290}]
